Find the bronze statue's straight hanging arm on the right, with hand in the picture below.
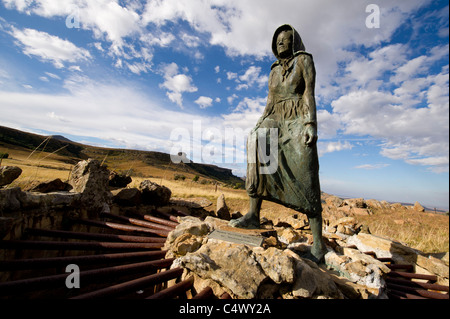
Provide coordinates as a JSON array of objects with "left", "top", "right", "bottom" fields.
[{"left": 302, "top": 54, "right": 317, "bottom": 145}]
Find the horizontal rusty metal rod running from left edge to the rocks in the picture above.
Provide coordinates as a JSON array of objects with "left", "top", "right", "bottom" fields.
[{"left": 0, "top": 240, "right": 164, "bottom": 250}]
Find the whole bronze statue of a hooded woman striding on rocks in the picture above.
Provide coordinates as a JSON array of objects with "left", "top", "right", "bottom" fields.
[{"left": 230, "top": 24, "right": 326, "bottom": 262}]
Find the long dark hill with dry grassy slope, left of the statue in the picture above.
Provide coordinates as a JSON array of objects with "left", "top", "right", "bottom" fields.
[{"left": 0, "top": 126, "right": 244, "bottom": 187}]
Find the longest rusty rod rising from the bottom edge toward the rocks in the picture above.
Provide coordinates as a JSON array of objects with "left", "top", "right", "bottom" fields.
[{"left": 71, "top": 268, "right": 183, "bottom": 299}]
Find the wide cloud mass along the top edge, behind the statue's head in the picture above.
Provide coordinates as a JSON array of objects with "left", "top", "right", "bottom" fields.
[{"left": 3, "top": 0, "right": 430, "bottom": 87}]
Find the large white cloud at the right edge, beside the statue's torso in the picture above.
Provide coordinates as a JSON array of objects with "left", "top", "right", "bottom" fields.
[{"left": 332, "top": 62, "right": 449, "bottom": 172}]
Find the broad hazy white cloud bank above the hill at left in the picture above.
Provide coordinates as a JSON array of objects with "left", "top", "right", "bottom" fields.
[{"left": 0, "top": 76, "right": 214, "bottom": 153}]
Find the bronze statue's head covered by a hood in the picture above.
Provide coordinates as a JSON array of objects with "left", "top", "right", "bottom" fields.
[{"left": 272, "top": 24, "right": 305, "bottom": 60}]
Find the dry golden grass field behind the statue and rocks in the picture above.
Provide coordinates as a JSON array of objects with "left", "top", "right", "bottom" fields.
[{"left": 0, "top": 148, "right": 449, "bottom": 253}]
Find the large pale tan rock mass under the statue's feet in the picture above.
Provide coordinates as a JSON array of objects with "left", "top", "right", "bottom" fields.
[{"left": 164, "top": 217, "right": 386, "bottom": 299}]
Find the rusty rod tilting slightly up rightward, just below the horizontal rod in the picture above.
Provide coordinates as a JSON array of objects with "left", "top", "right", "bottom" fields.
[{"left": 0, "top": 250, "right": 167, "bottom": 271}]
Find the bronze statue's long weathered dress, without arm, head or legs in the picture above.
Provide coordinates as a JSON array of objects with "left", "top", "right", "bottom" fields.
[{"left": 246, "top": 52, "right": 322, "bottom": 217}]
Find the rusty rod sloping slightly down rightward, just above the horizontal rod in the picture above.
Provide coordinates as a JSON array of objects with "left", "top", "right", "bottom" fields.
[{"left": 25, "top": 228, "right": 166, "bottom": 243}]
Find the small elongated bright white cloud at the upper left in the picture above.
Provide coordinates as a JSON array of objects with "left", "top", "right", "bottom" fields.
[{"left": 11, "top": 27, "right": 91, "bottom": 68}]
